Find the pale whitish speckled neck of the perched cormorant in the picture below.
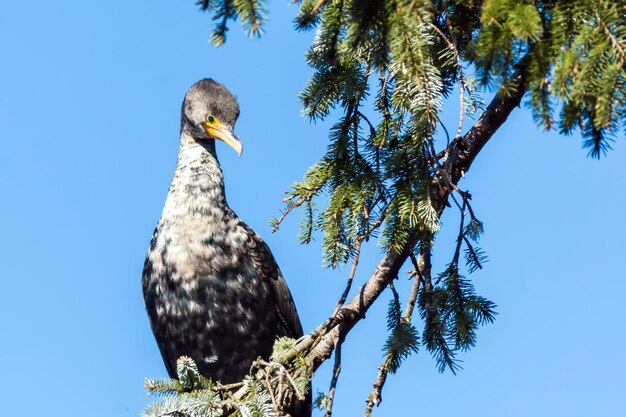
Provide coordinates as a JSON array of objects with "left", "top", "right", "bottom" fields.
[{"left": 163, "top": 129, "right": 227, "bottom": 218}]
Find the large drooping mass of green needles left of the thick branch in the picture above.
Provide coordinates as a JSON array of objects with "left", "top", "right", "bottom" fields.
[{"left": 290, "top": 0, "right": 472, "bottom": 267}]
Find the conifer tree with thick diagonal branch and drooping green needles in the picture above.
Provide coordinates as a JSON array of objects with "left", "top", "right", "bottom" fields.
[{"left": 145, "top": 0, "right": 626, "bottom": 416}]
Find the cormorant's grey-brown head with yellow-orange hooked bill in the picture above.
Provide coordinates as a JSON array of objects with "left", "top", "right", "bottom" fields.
[{"left": 182, "top": 78, "right": 243, "bottom": 156}]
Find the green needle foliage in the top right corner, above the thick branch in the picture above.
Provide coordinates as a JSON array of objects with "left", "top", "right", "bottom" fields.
[{"left": 473, "top": 0, "right": 626, "bottom": 158}]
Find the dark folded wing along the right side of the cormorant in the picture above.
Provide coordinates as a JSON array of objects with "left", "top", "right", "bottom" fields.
[{"left": 241, "top": 222, "right": 303, "bottom": 339}]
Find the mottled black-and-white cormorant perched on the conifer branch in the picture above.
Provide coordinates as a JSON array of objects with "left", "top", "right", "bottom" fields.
[{"left": 142, "top": 78, "right": 310, "bottom": 416}]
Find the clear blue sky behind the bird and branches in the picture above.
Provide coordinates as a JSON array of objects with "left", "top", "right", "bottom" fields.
[{"left": 0, "top": 0, "right": 626, "bottom": 417}]
